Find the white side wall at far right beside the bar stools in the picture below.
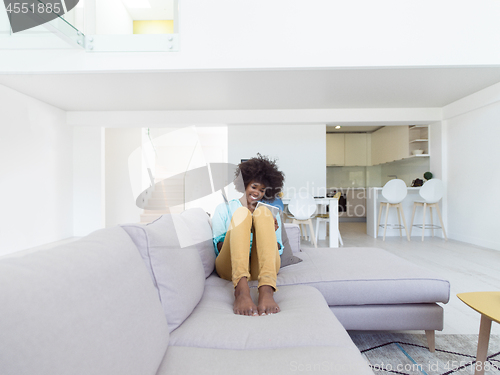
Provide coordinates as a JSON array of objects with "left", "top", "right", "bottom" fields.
[{"left": 443, "top": 85, "right": 500, "bottom": 250}]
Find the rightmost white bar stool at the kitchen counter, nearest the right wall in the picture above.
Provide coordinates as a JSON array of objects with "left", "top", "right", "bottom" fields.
[{"left": 410, "top": 178, "right": 448, "bottom": 241}]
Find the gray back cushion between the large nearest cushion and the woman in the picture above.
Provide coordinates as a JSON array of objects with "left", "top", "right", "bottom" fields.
[{"left": 122, "top": 215, "right": 205, "bottom": 332}]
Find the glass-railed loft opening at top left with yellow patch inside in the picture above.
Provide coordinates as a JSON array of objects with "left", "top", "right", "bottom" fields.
[{"left": 0, "top": 0, "right": 180, "bottom": 52}]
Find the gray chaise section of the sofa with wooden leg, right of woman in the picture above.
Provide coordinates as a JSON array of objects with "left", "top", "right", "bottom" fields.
[{"left": 268, "top": 224, "right": 450, "bottom": 351}]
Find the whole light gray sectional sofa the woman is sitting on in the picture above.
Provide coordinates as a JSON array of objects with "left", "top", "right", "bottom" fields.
[{"left": 0, "top": 209, "right": 449, "bottom": 375}]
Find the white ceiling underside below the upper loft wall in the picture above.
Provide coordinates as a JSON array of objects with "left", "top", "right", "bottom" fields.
[{"left": 0, "top": 67, "right": 500, "bottom": 111}]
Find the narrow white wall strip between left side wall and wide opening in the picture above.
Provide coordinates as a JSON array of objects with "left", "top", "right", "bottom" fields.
[{"left": 73, "top": 126, "right": 105, "bottom": 237}]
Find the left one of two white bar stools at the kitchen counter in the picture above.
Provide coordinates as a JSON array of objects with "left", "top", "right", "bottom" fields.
[{"left": 377, "top": 179, "right": 410, "bottom": 241}]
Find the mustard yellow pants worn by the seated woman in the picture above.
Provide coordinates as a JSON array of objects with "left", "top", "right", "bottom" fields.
[{"left": 215, "top": 207, "right": 281, "bottom": 290}]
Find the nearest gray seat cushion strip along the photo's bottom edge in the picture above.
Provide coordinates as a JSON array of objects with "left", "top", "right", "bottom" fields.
[{"left": 157, "top": 346, "right": 373, "bottom": 375}]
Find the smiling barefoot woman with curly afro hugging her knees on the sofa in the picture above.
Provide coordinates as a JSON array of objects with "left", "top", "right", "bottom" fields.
[{"left": 212, "top": 154, "right": 284, "bottom": 315}]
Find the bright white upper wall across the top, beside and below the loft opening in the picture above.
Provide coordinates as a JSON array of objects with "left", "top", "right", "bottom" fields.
[{"left": 2, "top": 0, "right": 500, "bottom": 71}]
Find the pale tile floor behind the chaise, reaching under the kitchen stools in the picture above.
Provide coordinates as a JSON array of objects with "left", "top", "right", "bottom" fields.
[{"left": 303, "top": 222, "right": 500, "bottom": 334}]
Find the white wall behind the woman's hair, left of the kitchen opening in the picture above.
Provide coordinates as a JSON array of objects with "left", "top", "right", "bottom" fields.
[{"left": 228, "top": 125, "right": 326, "bottom": 195}]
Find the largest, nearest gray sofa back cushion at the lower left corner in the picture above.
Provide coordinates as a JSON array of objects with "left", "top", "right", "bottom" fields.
[{"left": 0, "top": 227, "right": 169, "bottom": 375}]
